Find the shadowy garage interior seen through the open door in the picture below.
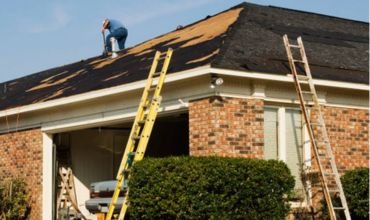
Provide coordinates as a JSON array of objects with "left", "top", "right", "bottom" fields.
[{"left": 53, "top": 113, "right": 189, "bottom": 216}]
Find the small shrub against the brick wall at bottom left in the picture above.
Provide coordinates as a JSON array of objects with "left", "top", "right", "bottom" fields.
[{"left": 0, "top": 178, "right": 29, "bottom": 220}]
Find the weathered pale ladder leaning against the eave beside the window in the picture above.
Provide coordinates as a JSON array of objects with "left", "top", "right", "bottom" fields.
[{"left": 283, "top": 35, "right": 351, "bottom": 220}]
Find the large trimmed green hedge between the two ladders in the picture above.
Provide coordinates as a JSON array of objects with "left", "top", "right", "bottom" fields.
[{"left": 129, "top": 157, "right": 294, "bottom": 219}]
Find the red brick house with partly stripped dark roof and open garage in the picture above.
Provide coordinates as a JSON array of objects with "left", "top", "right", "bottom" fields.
[{"left": 0, "top": 3, "right": 369, "bottom": 220}]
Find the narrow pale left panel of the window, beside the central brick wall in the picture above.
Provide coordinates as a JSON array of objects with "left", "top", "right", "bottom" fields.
[{"left": 264, "top": 107, "right": 278, "bottom": 159}]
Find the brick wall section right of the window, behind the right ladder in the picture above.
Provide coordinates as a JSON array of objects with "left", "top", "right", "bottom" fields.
[{"left": 312, "top": 106, "right": 369, "bottom": 214}]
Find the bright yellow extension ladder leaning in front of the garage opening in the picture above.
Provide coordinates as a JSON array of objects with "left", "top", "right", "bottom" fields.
[{"left": 105, "top": 48, "right": 173, "bottom": 220}]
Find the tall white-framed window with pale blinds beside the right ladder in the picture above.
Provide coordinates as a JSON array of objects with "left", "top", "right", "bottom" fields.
[{"left": 264, "top": 107, "right": 310, "bottom": 197}]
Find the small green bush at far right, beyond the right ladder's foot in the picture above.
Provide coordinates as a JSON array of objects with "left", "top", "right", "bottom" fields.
[{"left": 341, "top": 168, "right": 369, "bottom": 219}]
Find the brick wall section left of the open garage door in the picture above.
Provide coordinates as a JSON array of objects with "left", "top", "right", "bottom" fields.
[{"left": 0, "top": 129, "right": 42, "bottom": 220}]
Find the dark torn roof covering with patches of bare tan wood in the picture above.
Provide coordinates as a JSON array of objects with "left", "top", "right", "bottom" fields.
[{"left": 0, "top": 3, "right": 369, "bottom": 110}]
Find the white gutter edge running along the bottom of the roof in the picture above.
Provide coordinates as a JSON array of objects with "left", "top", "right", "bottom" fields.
[{"left": 0, "top": 65, "right": 369, "bottom": 117}]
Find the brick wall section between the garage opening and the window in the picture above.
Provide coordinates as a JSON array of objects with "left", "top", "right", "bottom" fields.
[{"left": 189, "top": 97, "right": 264, "bottom": 158}]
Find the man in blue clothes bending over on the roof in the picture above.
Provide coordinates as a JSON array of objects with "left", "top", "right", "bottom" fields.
[{"left": 101, "top": 18, "right": 128, "bottom": 52}]
